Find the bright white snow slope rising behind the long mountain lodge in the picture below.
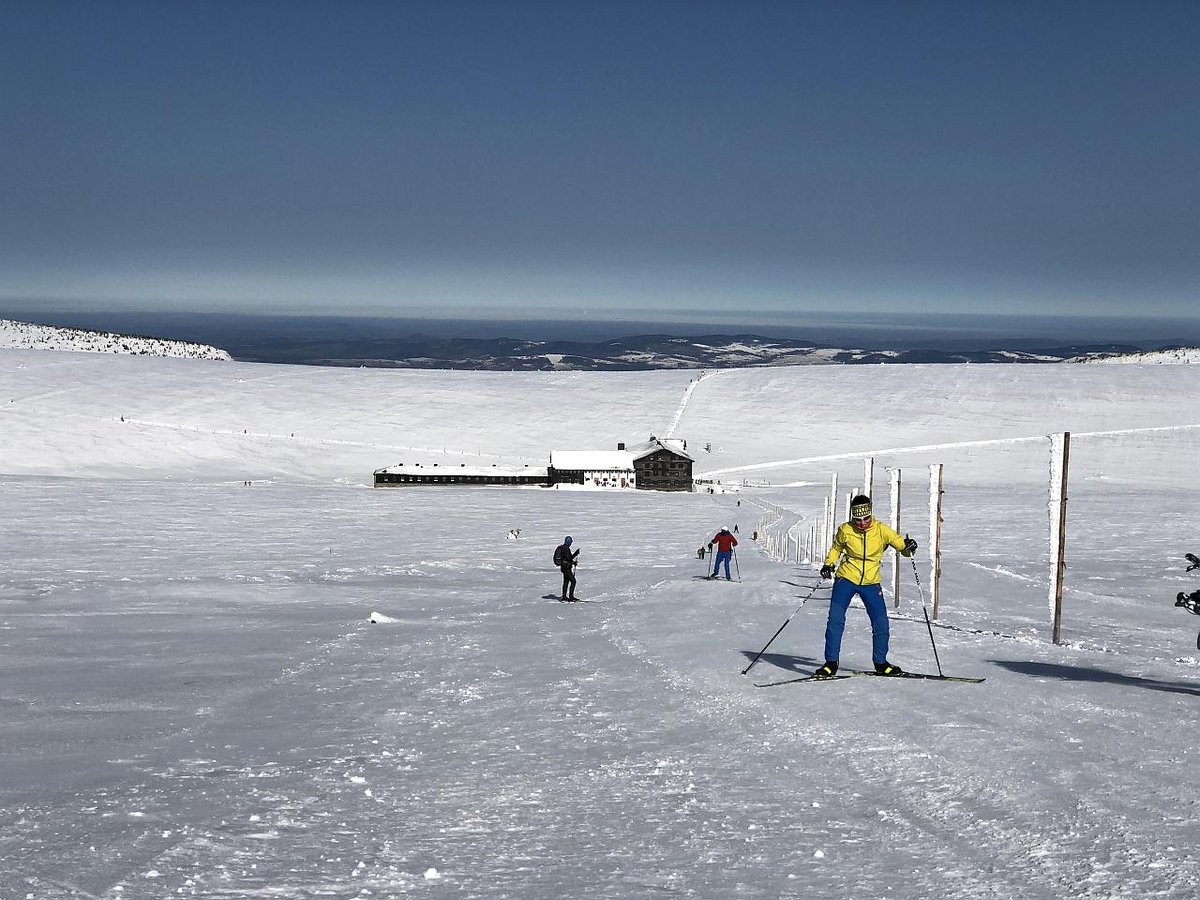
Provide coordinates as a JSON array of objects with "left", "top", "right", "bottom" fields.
[{"left": 0, "top": 350, "right": 1200, "bottom": 484}]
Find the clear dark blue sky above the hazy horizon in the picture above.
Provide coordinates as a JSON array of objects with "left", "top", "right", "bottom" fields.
[{"left": 0, "top": 0, "right": 1200, "bottom": 317}]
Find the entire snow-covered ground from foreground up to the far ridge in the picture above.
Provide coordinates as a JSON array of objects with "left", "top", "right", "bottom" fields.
[{"left": 0, "top": 349, "right": 1200, "bottom": 900}]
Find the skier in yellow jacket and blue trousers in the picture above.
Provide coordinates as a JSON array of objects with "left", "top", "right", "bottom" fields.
[{"left": 816, "top": 494, "right": 917, "bottom": 676}]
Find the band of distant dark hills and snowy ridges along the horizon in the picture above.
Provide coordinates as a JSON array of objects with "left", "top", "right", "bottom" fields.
[{"left": 0, "top": 319, "right": 1200, "bottom": 372}]
